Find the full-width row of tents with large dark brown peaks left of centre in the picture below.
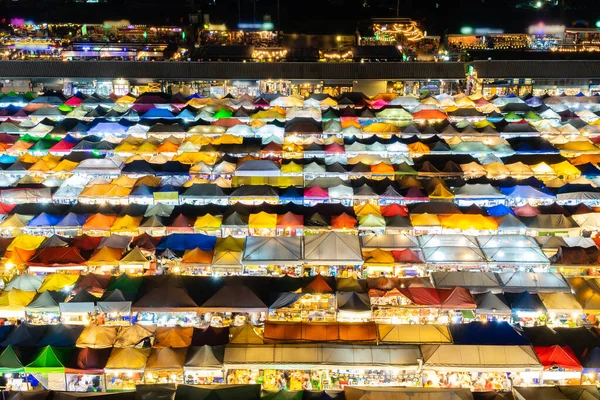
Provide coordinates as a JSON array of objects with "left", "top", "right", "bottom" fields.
[{"left": 0, "top": 272, "right": 600, "bottom": 316}]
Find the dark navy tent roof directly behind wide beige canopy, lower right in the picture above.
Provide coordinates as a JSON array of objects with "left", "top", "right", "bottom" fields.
[{"left": 449, "top": 322, "right": 531, "bottom": 346}]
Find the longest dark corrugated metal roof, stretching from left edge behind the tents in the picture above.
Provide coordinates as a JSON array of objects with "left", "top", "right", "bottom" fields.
[{"left": 0, "top": 61, "right": 465, "bottom": 80}]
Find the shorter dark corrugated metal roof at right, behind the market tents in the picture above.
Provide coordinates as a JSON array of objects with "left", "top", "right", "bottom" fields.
[{"left": 473, "top": 60, "right": 600, "bottom": 79}]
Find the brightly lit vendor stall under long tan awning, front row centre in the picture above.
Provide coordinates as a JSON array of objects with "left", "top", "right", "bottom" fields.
[{"left": 224, "top": 344, "right": 421, "bottom": 390}]
